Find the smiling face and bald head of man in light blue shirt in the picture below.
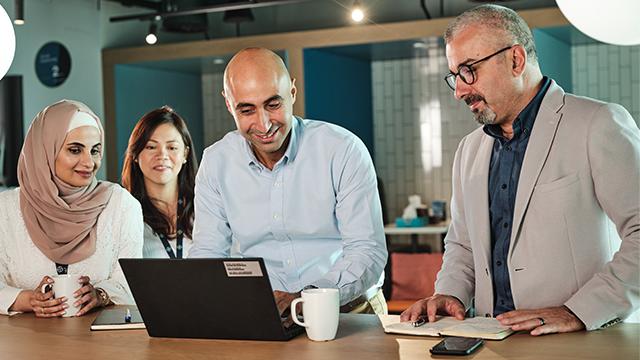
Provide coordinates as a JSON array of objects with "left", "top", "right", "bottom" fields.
[{"left": 223, "top": 49, "right": 296, "bottom": 166}]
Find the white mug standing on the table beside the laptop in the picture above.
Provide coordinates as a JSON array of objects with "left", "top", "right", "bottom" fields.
[{"left": 291, "top": 289, "right": 340, "bottom": 341}]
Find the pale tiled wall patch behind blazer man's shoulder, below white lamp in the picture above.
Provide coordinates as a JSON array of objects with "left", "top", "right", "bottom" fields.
[{"left": 571, "top": 44, "right": 640, "bottom": 124}]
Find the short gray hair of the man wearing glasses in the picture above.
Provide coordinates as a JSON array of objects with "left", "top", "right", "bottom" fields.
[{"left": 444, "top": 4, "right": 538, "bottom": 63}]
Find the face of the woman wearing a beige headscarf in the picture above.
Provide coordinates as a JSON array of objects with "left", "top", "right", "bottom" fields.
[{"left": 55, "top": 126, "right": 102, "bottom": 187}]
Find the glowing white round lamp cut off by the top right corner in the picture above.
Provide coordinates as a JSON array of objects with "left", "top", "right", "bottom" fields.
[{"left": 556, "top": 0, "right": 640, "bottom": 45}]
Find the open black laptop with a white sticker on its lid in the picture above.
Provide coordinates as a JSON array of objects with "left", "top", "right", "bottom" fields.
[{"left": 119, "top": 258, "right": 304, "bottom": 341}]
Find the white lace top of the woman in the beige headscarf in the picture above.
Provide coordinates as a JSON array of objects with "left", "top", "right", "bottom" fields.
[{"left": 0, "top": 186, "right": 144, "bottom": 315}]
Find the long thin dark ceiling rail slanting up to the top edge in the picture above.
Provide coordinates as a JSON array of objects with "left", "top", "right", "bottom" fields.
[{"left": 109, "top": 0, "right": 318, "bottom": 22}]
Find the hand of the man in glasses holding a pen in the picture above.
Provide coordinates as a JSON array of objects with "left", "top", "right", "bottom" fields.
[{"left": 400, "top": 294, "right": 464, "bottom": 322}]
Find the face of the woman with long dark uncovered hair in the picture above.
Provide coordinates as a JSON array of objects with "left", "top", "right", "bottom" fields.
[{"left": 137, "top": 123, "right": 189, "bottom": 188}]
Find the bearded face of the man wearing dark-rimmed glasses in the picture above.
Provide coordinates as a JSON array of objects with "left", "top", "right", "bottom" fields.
[{"left": 446, "top": 25, "right": 517, "bottom": 124}]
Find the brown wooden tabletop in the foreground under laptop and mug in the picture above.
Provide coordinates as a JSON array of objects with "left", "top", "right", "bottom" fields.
[{"left": 0, "top": 308, "right": 640, "bottom": 360}]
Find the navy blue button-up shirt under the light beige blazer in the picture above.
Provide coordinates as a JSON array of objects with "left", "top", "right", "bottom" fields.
[{"left": 483, "top": 76, "right": 551, "bottom": 316}]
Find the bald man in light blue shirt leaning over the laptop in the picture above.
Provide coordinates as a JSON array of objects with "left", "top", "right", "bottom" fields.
[{"left": 190, "top": 48, "right": 387, "bottom": 314}]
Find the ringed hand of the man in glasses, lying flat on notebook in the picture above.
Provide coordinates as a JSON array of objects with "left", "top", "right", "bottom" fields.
[{"left": 496, "top": 306, "right": 585, "bottom": 335}]
